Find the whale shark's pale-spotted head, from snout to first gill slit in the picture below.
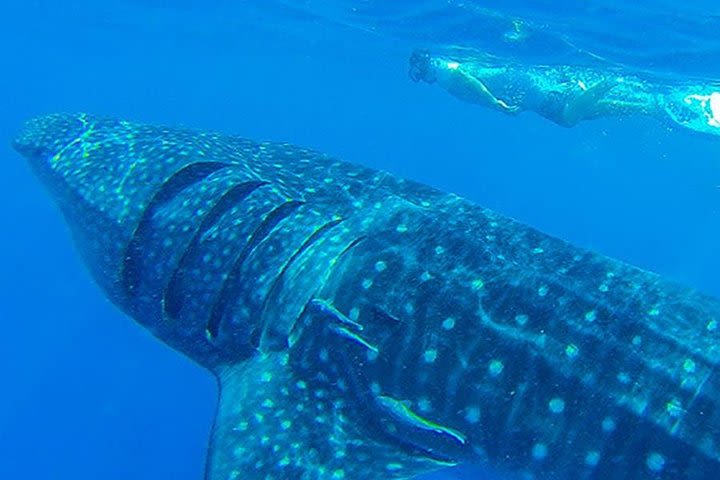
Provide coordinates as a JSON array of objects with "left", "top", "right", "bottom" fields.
[{"left": 13, "top": 114, "right": 235, "bottom": 323}]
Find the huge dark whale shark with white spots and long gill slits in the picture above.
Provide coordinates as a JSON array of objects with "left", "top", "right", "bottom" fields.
[{"left": 13, "top": 113, "right": 720, "bottom": 480}]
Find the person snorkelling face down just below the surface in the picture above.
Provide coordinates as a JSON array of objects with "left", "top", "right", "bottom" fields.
[{"left": 409, "top": 50, "right": 720, "bottom": 136}]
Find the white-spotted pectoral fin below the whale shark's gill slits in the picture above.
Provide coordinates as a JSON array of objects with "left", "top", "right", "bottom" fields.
[{"left": 206, "top": 352, "right": 448, "bottom": 480}]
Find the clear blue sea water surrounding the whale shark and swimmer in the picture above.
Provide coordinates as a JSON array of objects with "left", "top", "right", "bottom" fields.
[{"left": 0, "top": 0, "right": 720, "bottom": 480}]
